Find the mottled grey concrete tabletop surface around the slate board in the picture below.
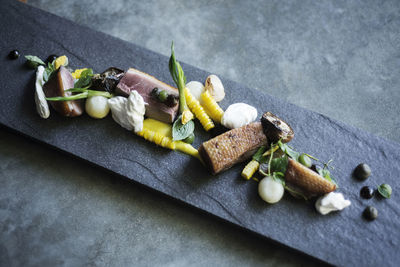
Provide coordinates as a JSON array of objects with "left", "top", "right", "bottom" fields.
[{"left": 0, "top": 0, "right": 400, "bottom": 266}]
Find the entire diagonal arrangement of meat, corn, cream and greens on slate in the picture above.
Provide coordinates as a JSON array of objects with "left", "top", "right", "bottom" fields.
[{"left": 19, "top": 44, "right": 391, "bottom": 218}]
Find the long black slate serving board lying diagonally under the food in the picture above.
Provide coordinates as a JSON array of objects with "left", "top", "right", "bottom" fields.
[{"left": 0, "top": 1, "right": 400, "bottom": 266}]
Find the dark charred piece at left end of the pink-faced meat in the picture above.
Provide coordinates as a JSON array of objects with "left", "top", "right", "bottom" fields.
[{"left": 92, "top": 67, "right": 124, "bottom": 93}]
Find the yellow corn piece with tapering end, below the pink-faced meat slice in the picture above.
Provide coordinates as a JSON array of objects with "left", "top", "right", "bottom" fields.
[{"left": 136, "top": 119, "right": 201, "bottom": 160}]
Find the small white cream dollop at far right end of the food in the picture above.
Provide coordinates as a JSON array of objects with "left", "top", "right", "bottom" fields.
[{"left": 315, "top": 192, "right": 351, "bottom": 215}]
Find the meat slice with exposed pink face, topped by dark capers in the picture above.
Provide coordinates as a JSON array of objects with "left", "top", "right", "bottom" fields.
[{"left": 115, "top": 68, "right": 179, "bottom": 123}]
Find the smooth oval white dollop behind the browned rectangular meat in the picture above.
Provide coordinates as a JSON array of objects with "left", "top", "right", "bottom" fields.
[{"left": 221, "top": 103, "right": 257, "bottom": 129}]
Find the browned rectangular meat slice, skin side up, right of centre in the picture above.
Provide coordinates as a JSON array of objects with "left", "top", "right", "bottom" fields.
[{"left": 199, "top": 122, "right": 267, "bottom": 174}]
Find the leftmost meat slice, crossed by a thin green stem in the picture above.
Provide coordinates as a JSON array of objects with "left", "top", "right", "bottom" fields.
[{"left": 43, "top": 66, "right": 83, "bottom": 117}]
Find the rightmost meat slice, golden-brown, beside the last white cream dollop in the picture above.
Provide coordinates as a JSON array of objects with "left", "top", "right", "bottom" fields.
[{"left": 285, "top": 158, "right": 336, "bottom": 197}]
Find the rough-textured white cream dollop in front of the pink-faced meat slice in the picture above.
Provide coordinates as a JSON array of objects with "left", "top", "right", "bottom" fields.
[{"left": 108, "top": 90, "right": 146, "bottom": 132}]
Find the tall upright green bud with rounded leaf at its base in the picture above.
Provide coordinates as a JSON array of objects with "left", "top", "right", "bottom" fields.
[{"left": 169, "top": 42, "right": 194, "bottom": 141}]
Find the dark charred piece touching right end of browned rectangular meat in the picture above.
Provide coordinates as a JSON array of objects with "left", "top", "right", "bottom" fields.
[{"left": 261, "top": 112, "right": 294, "bottom": 143}]
